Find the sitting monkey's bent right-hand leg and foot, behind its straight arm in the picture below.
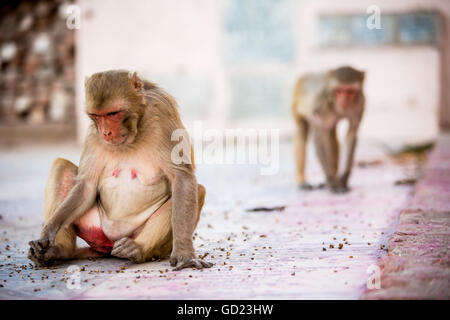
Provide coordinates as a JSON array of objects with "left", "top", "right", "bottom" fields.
[{"left": 111, "top": 184, "right": 212, "bottom": 268}]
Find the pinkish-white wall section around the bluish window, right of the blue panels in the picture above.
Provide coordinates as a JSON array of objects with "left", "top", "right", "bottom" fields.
[{"left": 296, "top": 0, "right": 450, "bottom": 142}]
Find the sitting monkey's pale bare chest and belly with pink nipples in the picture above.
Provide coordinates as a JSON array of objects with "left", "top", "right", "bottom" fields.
[{"left": 84, "top": 165, "right": 170, "bottom": 242}]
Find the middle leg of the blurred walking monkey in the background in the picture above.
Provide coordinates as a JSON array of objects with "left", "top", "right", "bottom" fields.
[{"left": 314, "top": 128, "right": 339, "bottom": 192}]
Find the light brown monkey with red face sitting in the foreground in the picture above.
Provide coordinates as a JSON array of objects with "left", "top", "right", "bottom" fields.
[{"left": 28, "top": 70, "right": 212, "bottom": 270}]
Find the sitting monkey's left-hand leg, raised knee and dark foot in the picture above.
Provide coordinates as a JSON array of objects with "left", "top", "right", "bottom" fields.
[{"left": 28, "top": 158, "right": 103, "bottom": 266}]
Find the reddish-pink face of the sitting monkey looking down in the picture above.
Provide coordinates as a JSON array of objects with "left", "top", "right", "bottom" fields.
[{"left": 89, "top": 109, "right": 128, "bottom": 145}]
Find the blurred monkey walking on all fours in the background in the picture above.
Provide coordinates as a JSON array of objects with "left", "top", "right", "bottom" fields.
[{"left": 292, "top": 66, "right": 365, "bottom": 193}]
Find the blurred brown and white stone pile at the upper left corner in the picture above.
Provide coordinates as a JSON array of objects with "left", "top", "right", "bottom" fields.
[{"left": 0, "top": 0, "right": 76, "bottom": 142}]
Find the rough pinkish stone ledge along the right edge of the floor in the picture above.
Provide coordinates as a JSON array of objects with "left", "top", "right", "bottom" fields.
[{"left": 363, "top": 134, "right": 450, "bottom": 299}]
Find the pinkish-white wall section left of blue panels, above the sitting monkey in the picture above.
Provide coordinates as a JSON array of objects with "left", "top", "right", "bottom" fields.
[{"left": 77, "top": 0, "right": 227, "bottom": 142}]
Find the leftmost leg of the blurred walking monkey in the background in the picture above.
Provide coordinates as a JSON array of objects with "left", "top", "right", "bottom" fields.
[{"left": 295, "top": 116, "right": 312, "bottom": 190}]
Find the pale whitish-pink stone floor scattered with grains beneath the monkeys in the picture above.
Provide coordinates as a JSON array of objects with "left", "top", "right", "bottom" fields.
[{"left": 0, "top": 142, "right": 416, "bottom": 299}]
